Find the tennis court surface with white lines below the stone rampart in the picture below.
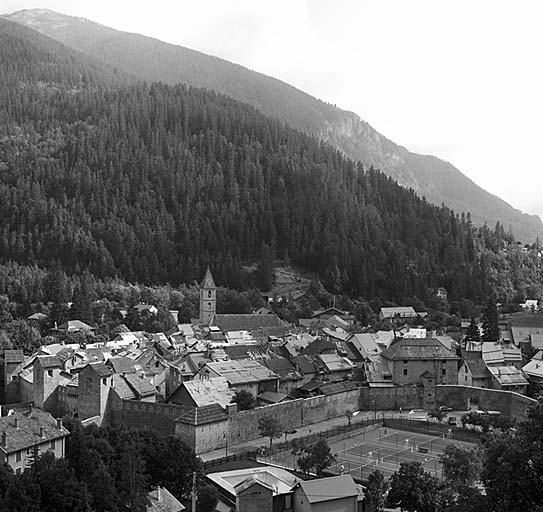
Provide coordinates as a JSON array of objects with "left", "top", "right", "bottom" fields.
[{"left": 328, "top": 427, "right": 473, "bottom": 479}]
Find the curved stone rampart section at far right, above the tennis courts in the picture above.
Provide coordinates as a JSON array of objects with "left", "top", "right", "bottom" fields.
[{"left": 436, "top": 385, "right": 536, "bottom": 420}]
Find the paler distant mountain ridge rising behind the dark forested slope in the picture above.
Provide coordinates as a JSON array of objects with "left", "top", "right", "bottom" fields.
[{"left": 5, "top": 9, "right": 543, "bottom": 242}]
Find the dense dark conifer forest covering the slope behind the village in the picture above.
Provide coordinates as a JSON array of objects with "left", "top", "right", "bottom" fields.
[{"left": 0, "top": 19, "right": 539, "bottom": 301}]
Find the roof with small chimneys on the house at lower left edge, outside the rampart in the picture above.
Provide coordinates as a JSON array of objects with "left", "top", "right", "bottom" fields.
[{"left": 0, "top": 409, "right": 69, "bottom": 453}]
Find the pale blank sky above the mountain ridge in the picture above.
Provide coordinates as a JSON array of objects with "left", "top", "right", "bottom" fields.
[{"left": 4, "top": 0, "right": 543, "bottom": 215}]
